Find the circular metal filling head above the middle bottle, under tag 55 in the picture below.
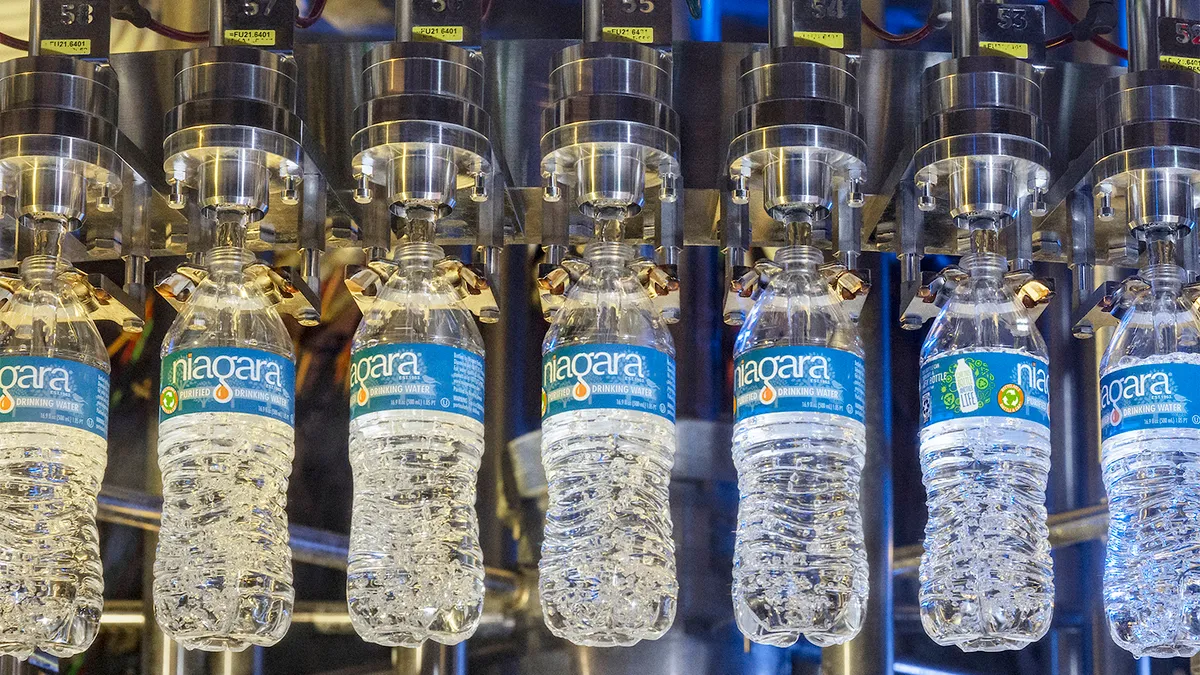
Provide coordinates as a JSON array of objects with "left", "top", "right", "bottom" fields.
[{"left": 541, "top": 42, "right": 680, "bottom": 220}]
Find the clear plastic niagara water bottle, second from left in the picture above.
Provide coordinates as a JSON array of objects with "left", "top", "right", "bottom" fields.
[{"left": 154, "top": 246, "right": 295, "bottom": 651}]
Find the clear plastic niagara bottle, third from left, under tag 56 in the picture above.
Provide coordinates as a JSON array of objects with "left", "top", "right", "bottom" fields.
[{"left": 346, "top": 244, "right": 484, "bottom": 647}]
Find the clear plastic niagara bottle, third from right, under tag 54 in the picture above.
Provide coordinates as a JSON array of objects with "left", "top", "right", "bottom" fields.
[{"left": 733, "top": 246, "right": 869, "bottom": 646}]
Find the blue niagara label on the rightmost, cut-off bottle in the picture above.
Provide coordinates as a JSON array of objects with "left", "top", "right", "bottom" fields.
[{"left": 1100, "top": 363, "right": 1200, "bottom": 441}]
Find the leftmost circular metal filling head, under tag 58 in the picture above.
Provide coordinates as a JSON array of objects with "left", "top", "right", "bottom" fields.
[{"left": 0, "top": 55, "right": 125, "bottom": 224}]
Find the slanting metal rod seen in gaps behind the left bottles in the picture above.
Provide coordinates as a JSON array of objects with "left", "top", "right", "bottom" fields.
[{"left": 96, "top": 486, "right": 528, "bottom": 607}]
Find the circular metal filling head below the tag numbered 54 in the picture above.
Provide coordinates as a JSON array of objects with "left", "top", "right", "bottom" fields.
[{"left": 728, "top": 47, "right": 866, "bottom": 222}]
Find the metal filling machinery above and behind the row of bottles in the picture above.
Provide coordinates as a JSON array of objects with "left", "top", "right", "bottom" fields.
[{"left": 0, "top": 0, "right": 1200, "bottom": 675}]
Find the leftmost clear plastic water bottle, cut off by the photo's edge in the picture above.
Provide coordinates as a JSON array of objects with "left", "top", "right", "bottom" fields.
[{"left": 0, "top": 256, "right": 108, "bottom": 658}]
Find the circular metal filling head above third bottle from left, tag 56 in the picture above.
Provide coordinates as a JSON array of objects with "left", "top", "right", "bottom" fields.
[{"left": 352, "top": 42, "right": 492, "bottom": 215}]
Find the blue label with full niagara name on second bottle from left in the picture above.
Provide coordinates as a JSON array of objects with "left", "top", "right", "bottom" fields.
[{"left": 158, "top": 347, "right": 296, "bottom": 425}]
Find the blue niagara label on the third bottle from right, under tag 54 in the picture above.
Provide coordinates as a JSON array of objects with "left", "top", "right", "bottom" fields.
[{"left": 733, "top": 347, "right": 866, "bottom": 423}]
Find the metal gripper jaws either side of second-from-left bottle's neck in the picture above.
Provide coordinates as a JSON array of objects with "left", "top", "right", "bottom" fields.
[{"left": 155, "top": 263, "right": 320, "bottom": 325}]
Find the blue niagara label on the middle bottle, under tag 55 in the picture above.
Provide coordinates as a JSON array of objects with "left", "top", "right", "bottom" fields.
[{"left": 541, "top": 345, "right": 676, "bottom": 422}]
